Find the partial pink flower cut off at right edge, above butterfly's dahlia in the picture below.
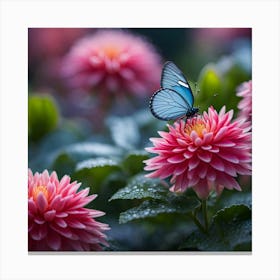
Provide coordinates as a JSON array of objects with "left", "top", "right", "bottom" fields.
[{"left": 236, "top": 80, "right": 252, "bottom": 121}]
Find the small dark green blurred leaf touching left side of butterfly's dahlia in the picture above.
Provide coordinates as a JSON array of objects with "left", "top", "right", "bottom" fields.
[{"left": 122, "top": 151, "right": 149, "bottom": 175}]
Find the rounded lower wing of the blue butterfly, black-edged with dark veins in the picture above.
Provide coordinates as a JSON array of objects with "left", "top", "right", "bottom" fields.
[{"left": 150, "top": 88, "right": 191, "bottom": 121}]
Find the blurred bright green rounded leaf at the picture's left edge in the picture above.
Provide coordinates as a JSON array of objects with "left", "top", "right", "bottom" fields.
[{"left": 28, "top": 95, "right": 59, "bottom": 141}]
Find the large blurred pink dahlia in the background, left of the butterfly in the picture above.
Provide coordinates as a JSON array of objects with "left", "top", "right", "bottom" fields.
[{"left": 62, "top": 30, "right": 161, "bottom": 95}]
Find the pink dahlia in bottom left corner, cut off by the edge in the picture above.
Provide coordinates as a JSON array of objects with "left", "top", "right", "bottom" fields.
[{"left": 28, "top": 169, "right": 109, "bottom": 251}]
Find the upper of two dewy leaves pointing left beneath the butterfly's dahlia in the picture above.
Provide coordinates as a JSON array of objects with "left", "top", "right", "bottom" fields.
[{"left": 109, "top": 174, "right": 168, "bottom": 201}]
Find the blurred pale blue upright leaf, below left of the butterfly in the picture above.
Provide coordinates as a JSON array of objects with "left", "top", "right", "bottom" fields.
[{"left": 107, "top": 117, "right": 140, "bottom": 150}]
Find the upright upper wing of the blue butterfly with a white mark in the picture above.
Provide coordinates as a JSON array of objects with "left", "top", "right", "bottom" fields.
[{"left": 161, "top": 61, "right": 194, "bottom": 107}]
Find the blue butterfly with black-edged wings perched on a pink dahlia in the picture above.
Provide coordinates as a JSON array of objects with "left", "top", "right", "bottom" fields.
[{"left": 150, "top": 61, "right": 198, "bottom": 121}]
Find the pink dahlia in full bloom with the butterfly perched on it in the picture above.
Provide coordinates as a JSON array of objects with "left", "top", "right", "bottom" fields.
[{"left": 145, "top": 107, "right": 251, "bottom": 199}]
